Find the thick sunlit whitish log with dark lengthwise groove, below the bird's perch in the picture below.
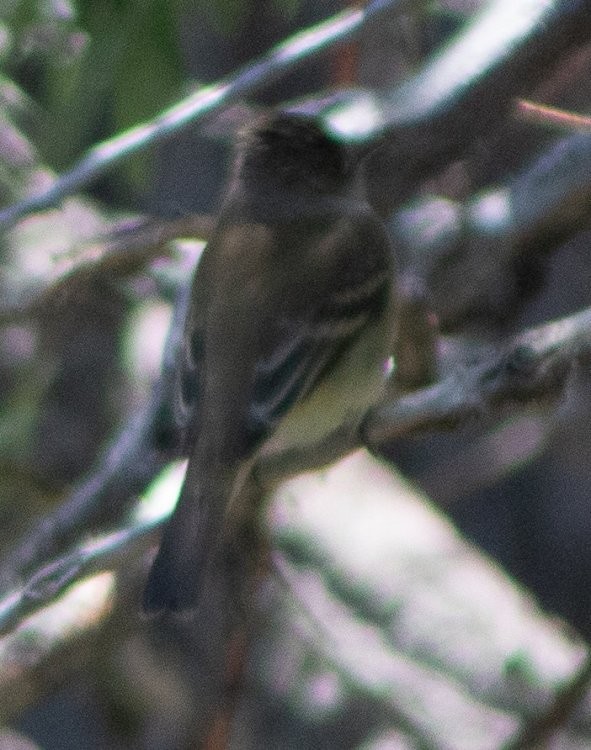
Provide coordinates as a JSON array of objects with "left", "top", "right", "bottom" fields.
[{"left": 262, "top": 451, "right": 589, "bottom": 750}]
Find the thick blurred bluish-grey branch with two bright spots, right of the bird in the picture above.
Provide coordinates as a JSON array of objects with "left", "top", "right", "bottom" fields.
[{"left": 390, "top": 129, "right": 591, "bottom": 329}]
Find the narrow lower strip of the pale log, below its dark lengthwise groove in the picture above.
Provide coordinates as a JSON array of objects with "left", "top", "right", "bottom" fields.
[{"left": 273, "top": 554, "right": 518, "bottom": 750}]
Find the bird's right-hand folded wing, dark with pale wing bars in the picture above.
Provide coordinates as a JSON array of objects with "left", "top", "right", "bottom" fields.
[{"left": 243, "top": 213, "right": 392, "bottom": 434}]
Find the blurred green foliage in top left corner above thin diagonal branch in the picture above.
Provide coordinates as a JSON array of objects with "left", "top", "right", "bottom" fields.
[{"left": 0, "top": 0, "right": 186, "bottom": 194}]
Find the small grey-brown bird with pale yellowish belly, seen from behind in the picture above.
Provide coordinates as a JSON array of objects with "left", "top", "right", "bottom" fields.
[{"left": 144, "top": 112, "right": 395, "bottom": 612}]
